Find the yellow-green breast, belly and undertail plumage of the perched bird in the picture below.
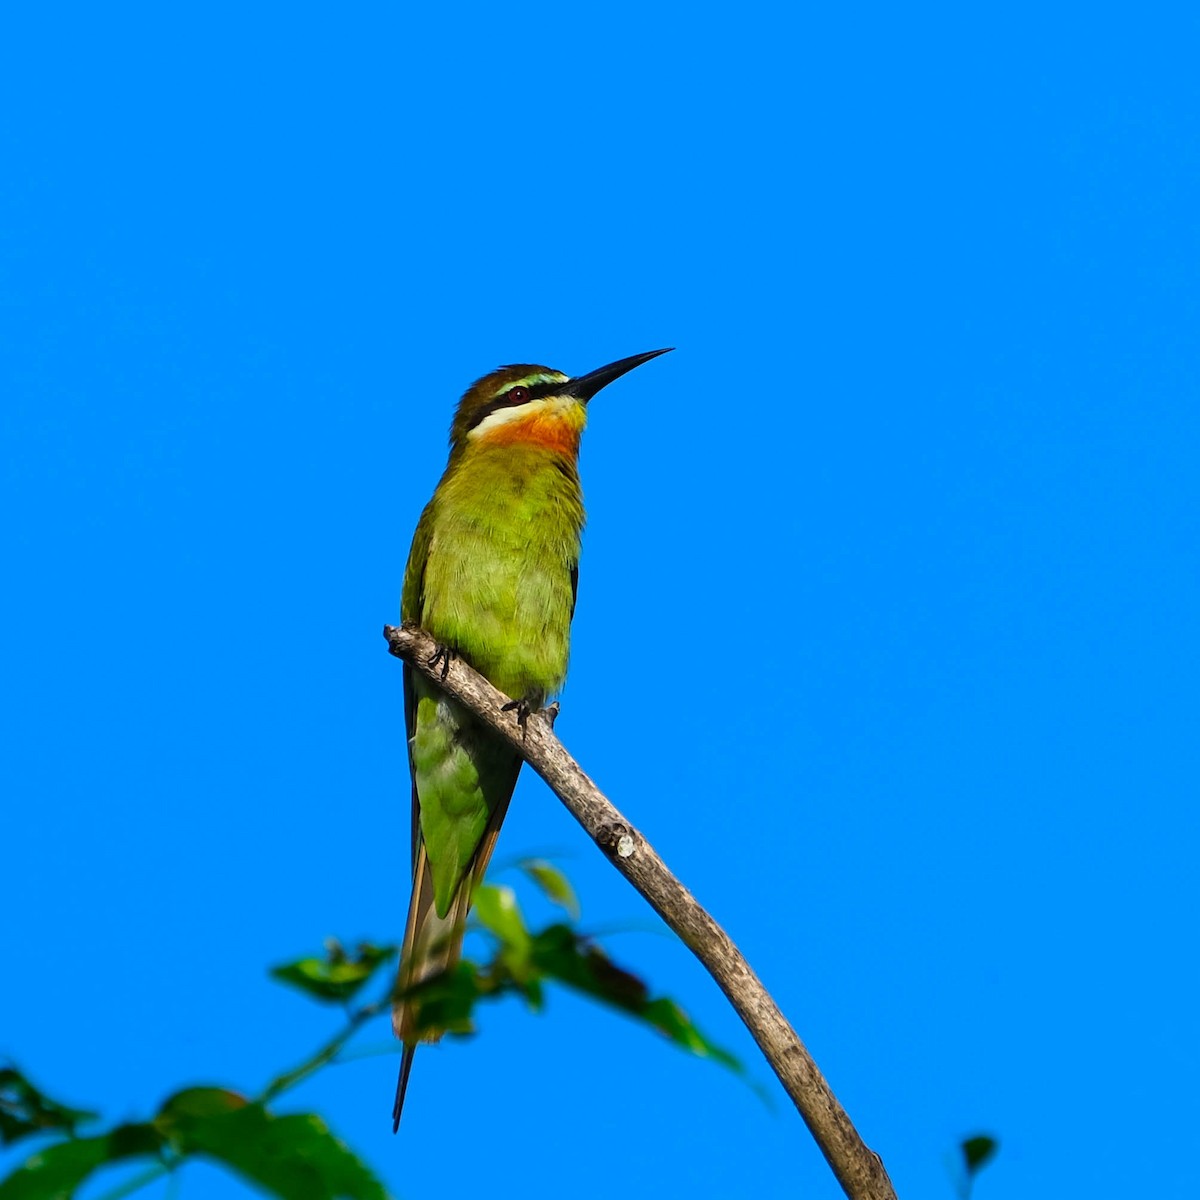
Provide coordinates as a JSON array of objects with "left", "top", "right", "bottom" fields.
[{"left": 403, "top": 406, "right": 583, "bottom": 917}]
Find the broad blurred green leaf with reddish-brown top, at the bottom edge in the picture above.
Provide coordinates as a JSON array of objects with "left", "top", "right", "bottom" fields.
[{"left": 168, "top": 1104, "right": 389, "bottom": 1200}]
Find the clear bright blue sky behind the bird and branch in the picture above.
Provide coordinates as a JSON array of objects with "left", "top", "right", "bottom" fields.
[{"left": 0, "top": 0, "right": 1200, "bottom": 1200}]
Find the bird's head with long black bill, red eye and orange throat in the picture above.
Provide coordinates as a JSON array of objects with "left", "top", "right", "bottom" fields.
[{"left": 450, "top": 350, "right": 667, "bottom": 456}]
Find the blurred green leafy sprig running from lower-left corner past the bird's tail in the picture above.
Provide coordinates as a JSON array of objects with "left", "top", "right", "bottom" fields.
[{"left": 0, "top": 860, "right": 740, "bottom": 1200}]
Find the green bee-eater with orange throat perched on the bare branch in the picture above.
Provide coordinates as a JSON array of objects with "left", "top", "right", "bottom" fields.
[{"left": 392, "top": 350, "right": 667, "bottom": 1129}]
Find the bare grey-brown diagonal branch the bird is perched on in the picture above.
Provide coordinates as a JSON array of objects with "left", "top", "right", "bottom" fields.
[{"left": 383, "top": 625, "right": 896, "bottom": 1200}]
